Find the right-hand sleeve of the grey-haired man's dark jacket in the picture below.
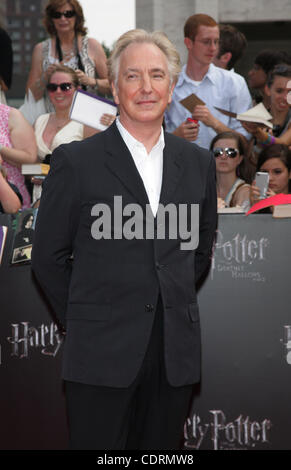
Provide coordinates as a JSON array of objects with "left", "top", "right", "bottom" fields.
[{"left": 195, "top": 156, "right": 217, "bottom": 282}]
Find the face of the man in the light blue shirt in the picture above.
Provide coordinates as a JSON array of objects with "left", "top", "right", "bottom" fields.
[{"left": 184, "top": 25, "right": 219, "bottom": 66}]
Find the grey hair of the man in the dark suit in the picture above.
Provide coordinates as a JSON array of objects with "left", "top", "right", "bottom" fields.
[{"left": 108, "top": 29, "right": 181, "bottom": 87}]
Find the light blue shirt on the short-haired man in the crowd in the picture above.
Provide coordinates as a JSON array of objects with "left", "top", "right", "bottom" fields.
[{"left": 165, "top": 64, "right": 252, "bottom": 149}]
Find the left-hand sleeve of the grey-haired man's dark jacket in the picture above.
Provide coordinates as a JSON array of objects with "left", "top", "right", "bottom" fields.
[{"left": 32, "top": 146, "right": 80, "bottom": 325}]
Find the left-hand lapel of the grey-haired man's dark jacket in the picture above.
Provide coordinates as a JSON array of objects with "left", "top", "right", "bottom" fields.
[{"left": 105, "top": 123, "right": 149, "bottom": 206}]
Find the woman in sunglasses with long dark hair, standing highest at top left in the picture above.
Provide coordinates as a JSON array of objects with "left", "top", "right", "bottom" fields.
[{"left": 27, "top": 0, "right": 110, "bottom": 121}]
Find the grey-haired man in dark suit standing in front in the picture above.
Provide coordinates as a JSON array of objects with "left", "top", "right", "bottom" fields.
[{"left": 33, "top": 30, "right": 216, "bottom": 449}]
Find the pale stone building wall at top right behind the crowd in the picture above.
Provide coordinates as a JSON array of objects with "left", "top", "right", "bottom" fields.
[{"left": 136, "top": 0, "right": 291, "bottom": 75}]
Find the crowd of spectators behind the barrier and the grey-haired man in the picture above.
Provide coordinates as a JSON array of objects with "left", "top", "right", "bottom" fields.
[{"left": 0, "top": 0, "right": 291, "bottom": 213}]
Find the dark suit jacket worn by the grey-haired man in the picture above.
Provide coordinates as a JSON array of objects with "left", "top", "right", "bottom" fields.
[{"left": 32, "top": 124, "right": 217, "bottom": 387}]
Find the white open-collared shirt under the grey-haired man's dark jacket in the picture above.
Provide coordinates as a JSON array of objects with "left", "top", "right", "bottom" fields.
[{"left": 116, "top": 117, "right": 165, "bottom": 216}]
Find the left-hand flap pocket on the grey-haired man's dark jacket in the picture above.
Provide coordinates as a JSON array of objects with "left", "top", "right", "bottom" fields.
[{"left": 66, "top": 303, "right": 111, "bottom": 322}]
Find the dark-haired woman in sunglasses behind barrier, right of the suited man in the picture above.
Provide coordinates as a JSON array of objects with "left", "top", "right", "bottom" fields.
[{"left": 210, "top": 132, "right": 250, "bottom": 210}]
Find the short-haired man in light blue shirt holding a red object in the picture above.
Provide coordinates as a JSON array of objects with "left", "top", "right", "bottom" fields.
[{"left": 165, "top": 14, "right": 252, "bottom": 148}]
